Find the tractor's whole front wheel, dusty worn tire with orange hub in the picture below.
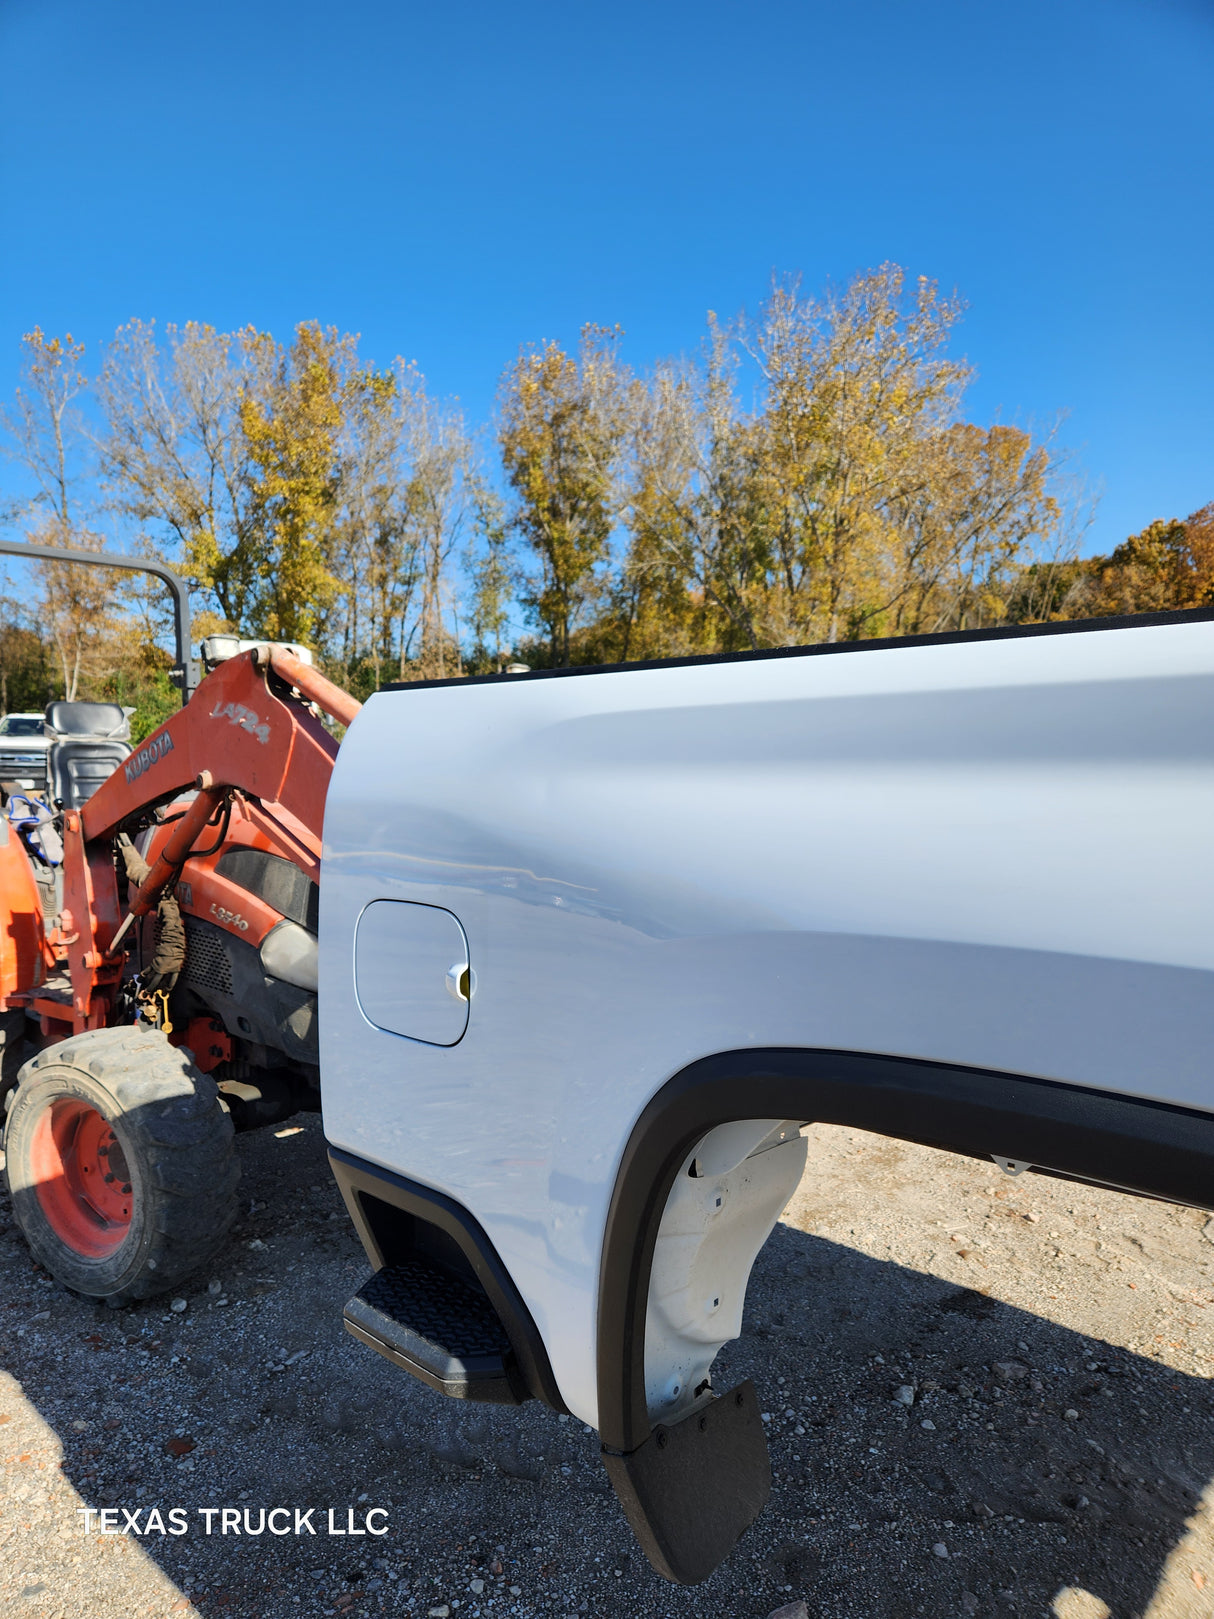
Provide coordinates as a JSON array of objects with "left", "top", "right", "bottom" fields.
[{"left": 5, "top": 1026, "right": 240, "bottom": 1305}]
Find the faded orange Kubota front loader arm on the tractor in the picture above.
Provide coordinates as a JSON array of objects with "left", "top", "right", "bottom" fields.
[{"left": 55, "top": 646, "right": 361, "bottom": 1033}]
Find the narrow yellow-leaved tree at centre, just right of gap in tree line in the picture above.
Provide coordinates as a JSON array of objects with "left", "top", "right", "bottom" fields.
[{"left": 499, "top": 325, "right": 628, "bottom": 667}]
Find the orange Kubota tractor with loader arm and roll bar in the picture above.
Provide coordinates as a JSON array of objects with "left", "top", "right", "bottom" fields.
[{"left": 0, "top": 544, "right": 359, "bottom": 1305}]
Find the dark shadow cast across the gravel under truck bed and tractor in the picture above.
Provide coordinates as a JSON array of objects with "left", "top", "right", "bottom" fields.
[{"left": 0, "top": 1120, "right": 1214, "bottom": 1619}]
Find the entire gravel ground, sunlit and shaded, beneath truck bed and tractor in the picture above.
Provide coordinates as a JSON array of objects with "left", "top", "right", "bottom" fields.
[{"left": 0, "top": 1119, "right": 1214, "bottom": 1619}]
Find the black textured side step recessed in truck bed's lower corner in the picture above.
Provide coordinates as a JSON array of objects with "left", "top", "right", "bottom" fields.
[{"left": 343, "top": 1258, "right": 528, "bottom": 1405}]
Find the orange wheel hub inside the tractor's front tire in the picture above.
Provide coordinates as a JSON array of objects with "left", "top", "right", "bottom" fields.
[{"left": 31, "top": 1096, "right": 134, "bottom": 1260}]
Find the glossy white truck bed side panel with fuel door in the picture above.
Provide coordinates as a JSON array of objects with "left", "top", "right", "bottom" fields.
[{"left": 320, "top": 620, "right": 1214, "bottom": 1580}]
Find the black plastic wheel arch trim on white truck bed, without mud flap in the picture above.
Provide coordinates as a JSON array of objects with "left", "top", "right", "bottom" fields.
[{"left": 597, "top": 1047, "right": 1214, "bottom": 1454}]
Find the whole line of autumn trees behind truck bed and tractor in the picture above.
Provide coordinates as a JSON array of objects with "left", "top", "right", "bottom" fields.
[{"left": 0, "top": 266, "right": 1214, "bottom": 732}]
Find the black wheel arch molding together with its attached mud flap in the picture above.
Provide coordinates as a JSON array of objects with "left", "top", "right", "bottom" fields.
[{"left": 596, "top": 1047, "right": 1214, "bottom": 1583}]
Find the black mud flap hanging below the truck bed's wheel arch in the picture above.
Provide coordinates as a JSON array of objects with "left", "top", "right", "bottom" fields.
[{"left": 602, "top": 1381, "right": 772, "bottom": 1585}]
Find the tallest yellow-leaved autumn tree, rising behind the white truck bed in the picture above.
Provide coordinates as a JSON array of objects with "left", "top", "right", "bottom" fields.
[{"left": 740, "top": 264, "right": 970, "bottom": 644}]
